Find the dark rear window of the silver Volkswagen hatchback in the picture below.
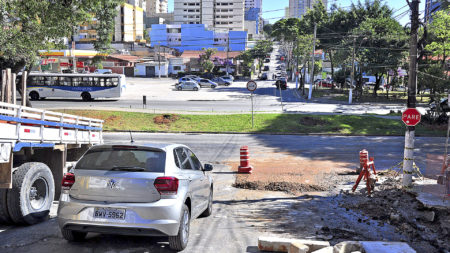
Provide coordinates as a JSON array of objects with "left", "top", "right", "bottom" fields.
[{"left": 75, "top": 149, "right": 166, "bottom": 172}]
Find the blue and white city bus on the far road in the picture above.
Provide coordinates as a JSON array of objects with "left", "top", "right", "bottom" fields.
[{"left": 27, "top": 72, "right": 126, "bottom": 101}]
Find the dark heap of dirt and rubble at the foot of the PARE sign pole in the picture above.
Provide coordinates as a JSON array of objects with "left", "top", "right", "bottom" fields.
[{"left": 340, "top": 177, "right": 450, "bottom": 252}]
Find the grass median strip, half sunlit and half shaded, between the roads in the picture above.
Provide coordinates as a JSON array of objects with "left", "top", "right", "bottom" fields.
[{"left": 59, "top": 110, "right": 447, "bottom": 136}]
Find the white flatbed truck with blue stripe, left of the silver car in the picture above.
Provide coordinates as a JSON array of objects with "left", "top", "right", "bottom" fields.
[{"left": 0, "top": 102, "right": 103, "bottom": 224}]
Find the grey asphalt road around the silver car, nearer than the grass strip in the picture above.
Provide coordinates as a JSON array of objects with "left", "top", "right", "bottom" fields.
[{"left": 0, "top": 133, "right": 444, "bottom": 253}]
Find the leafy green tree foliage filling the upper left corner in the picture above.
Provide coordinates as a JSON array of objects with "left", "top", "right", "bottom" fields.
[{"left": 0, "top": 0, "right": 123, "bottom": 72}]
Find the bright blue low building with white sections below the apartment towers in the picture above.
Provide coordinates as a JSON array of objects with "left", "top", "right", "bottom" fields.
[{"left": 150, "top": 24, "right": 247, "bottom": 52}]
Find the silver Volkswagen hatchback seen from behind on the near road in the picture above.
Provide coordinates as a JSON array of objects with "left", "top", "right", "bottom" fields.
[{"left": 58, "top": 144, "right": 213, "bottom": 250}]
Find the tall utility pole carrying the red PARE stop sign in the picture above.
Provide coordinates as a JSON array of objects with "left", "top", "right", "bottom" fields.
[{"left": 402, "top": 0, "right": 419, "bottom": 186}]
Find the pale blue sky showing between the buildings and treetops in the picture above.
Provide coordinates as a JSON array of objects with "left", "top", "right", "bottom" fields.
[{"left": 169, "top": 0, "right": 425, "bottom": 25}]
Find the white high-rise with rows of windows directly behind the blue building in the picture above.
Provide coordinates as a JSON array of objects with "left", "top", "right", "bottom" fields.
[{"left": 174, "top": 0, "right": 244, "bottom": 31}]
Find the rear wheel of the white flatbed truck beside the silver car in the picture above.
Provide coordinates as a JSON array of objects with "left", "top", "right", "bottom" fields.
[{"left": 7, "top": 162, "right": 55, "bottom": 225}]
